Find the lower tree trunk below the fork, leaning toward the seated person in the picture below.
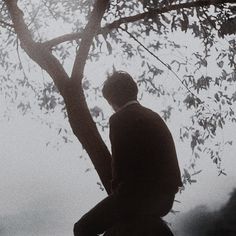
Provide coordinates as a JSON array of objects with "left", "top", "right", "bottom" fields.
[{"left": 63, "top": 80, "right": 111, "bottom": 194}]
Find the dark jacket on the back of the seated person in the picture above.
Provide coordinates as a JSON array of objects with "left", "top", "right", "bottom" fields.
[{"left": 110, "top": 104, "right": 182, "bottom": 192}]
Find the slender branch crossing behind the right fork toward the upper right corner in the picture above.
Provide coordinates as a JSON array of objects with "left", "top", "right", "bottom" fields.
[{"left": 41, "top": 0, "right": 235, "bottom": 48}]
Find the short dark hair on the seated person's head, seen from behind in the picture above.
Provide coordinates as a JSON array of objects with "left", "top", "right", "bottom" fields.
[{"left": 102, "top": 71, "right": 138, "bottom": 106}]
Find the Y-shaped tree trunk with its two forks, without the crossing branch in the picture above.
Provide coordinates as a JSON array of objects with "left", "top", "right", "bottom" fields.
[{"left": 5, "top": 0, "right": 111, "bottom": 193}]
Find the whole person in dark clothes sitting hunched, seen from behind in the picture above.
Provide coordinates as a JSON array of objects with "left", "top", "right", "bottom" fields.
[{"left": 74, "top": 71, "right": 182, "bottom": 236}]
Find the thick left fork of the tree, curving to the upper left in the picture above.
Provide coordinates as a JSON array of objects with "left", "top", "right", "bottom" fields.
[{"left": 5, "top": 0, "right": 69, "bottom": 94}]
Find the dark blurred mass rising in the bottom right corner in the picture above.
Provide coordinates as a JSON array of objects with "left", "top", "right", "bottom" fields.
[{"left": 175, "top": 189, "right": 236, "bottom": 236}]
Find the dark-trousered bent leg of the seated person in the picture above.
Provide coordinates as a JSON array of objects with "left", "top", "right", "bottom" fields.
[{"left": 74, "top": 188, "right": 174, "bottom": 236}]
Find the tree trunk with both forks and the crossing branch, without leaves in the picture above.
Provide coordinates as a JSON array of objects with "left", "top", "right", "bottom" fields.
[{"left": 4, "top": 0, "right": 235, "bottom": 201}]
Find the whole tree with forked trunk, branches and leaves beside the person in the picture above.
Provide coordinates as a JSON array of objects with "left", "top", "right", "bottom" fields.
[{"left": 0, "top": 0, "right": 236, "bottom": 234}]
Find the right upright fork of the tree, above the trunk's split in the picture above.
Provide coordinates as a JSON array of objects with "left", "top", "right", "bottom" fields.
[{"left": 71, "top": 0, "right": 109, "bottom": 80}]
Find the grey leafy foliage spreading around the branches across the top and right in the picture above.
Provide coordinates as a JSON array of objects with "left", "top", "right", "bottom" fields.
[{"left": 0, "top": 0, "right": 236, "bottom": 188}]
